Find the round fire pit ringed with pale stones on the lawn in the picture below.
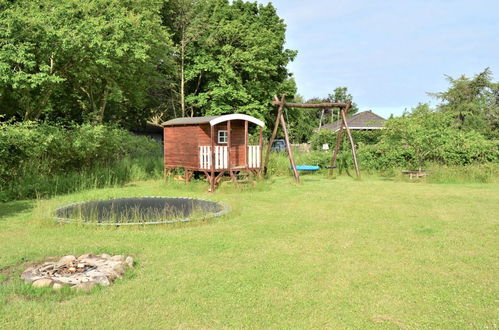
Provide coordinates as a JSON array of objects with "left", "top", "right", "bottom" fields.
[{"left": 21, "top": 253, "right": 133, "bottom": 291}]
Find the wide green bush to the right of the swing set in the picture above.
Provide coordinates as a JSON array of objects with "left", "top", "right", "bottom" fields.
[{"left": 358, "top": 112, "right": 499, "bottom": 170}]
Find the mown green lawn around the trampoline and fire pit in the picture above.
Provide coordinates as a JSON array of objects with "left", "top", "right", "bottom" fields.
[{"left": 0, "top": 175, "right": 499, "bottom": 329}]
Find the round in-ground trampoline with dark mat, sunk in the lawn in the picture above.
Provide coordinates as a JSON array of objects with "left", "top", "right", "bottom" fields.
[{"left": 55, "top": 197, "right": 229, "bottom": 226}]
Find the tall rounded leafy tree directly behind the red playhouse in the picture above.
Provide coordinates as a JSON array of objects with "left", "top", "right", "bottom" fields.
[{"left": 181, "top": 0, "right": 296, "bottom": 120}]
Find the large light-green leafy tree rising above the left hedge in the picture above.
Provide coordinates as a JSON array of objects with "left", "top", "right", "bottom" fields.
[{"left": 0, "top": 0, "right": 170, "bottom": 122}]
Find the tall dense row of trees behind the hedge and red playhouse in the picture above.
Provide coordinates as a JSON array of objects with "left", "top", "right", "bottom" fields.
[{"left": 0, "top": 0, "right": 296, "bottom": 126}]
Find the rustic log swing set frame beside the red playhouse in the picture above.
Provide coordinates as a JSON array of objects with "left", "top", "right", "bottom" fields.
[{"left": 263, "top": 94, "right": 360, "bottom": 183}]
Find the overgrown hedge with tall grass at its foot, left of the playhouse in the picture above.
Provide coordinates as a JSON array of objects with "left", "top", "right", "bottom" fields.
[{"left": 0, "top": 122, "right": 162, "bottom": 200}]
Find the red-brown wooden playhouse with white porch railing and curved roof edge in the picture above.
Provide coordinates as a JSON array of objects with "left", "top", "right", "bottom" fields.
[{"left": 163, "top": 114, "right": 265, "bottom": 191}]
